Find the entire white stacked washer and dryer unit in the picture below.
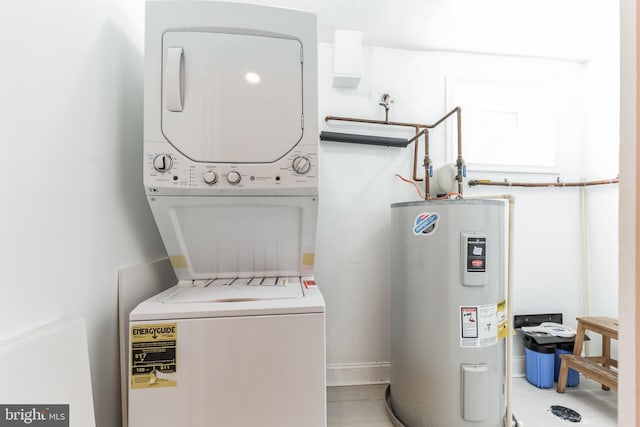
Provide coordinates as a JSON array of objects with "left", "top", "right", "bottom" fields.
[{"left": 128, "top": 1, "right": 326, "bottom": 427}]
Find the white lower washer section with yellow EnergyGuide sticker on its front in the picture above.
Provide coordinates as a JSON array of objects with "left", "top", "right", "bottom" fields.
[{"left": 129, "top": 278, "right": 326, "bottom": 427}]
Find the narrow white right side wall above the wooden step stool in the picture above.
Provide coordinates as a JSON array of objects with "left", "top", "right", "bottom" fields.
[{"left": 585, "top": 1, "right": 620, "bottom": 328}]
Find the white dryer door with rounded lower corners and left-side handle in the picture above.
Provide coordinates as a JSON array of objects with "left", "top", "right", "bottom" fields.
[{"left": 162, "top": 31, "right": 303, "bottom": 163}]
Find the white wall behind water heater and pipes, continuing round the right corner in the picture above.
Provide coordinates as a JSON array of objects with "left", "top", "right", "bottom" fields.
[{"left": 316, "top": 40, "right": 617, "bottom": 382}]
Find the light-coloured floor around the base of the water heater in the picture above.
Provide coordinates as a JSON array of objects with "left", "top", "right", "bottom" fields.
[{"left": 327, "top": 377, "right": 618, "bottom": 427}]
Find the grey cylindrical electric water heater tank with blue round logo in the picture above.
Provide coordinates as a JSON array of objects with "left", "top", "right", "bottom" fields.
[{"left": 389, "top": 199, "right": 508, "bottom": 427}]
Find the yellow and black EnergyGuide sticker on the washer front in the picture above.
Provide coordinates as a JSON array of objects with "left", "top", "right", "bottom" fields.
[{"left": 129, "top": 323, "right": 178, "bottom": 388}]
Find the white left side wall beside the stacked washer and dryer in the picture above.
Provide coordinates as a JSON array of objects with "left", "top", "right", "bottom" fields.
[{"left": 0, "top": 0, "right": 158, "bottom": 427}]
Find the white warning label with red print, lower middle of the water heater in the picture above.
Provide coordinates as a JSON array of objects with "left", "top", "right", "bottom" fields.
[{"left": 460, "top": 304, "right": 498, "bottom": 348}]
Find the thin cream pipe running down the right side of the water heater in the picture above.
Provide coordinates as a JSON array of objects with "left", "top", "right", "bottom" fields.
[{"left": 471, "top": 194, "right": 520, "bottom": 427}]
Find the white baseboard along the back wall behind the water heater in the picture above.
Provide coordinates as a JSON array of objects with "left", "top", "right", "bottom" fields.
[{"left": 327, "top": 356, "right": 526, "bottom": 387}]
